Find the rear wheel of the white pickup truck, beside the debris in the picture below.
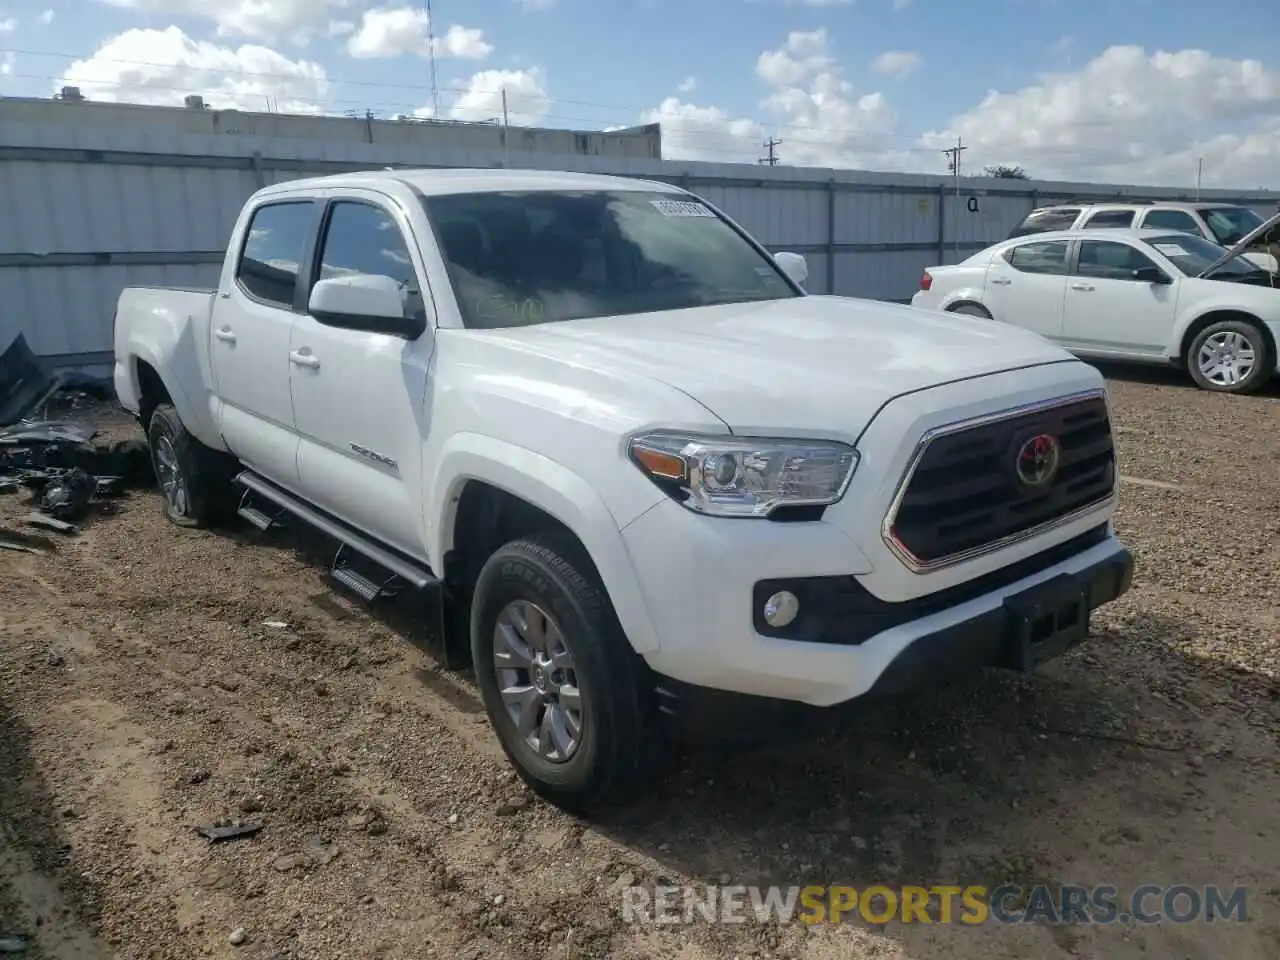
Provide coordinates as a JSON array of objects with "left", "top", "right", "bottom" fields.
[{"left": 147, "top": 403, "right": 232, "bottom": 527}]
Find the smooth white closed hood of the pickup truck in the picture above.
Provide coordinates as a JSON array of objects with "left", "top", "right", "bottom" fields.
[{"left": 484, "top": 296, "right": 1071, "bottom": 439}]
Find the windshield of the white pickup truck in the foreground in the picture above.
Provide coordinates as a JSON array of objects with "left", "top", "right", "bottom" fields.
[{"left": 424, "top": 191, "right": 800, "bottom": 329}]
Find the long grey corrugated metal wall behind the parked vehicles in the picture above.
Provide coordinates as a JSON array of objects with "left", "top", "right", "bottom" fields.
[{"left": 0, "top": 106, "right": 1280, "bottom": 366}]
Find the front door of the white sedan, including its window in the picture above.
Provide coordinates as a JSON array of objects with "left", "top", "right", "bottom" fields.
[{"left": 1062, "top": 239, "right": 1178, "bottom": 357}]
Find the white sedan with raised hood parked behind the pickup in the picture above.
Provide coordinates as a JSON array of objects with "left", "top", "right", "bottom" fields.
[{"left": 911, "top": 215, "right": 1280, "bottom": 393}]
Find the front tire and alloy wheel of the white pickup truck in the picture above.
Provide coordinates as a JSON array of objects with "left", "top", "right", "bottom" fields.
[{"left": 471, "top": 532, "right": 663, "bottom": 814}]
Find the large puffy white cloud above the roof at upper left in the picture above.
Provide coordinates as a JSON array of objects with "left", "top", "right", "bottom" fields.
[{"left": 54, "top": 27, "right": 328, "bottom": 114}]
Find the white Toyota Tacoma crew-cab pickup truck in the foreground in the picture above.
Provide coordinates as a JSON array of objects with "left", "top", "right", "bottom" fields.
[{"left": 115, "top": 170, "right": 1133, "bottom": 810}]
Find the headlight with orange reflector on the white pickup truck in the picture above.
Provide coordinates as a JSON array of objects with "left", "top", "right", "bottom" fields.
[{"left": 630, "top": 433, "right": 858, "bottom": 517}]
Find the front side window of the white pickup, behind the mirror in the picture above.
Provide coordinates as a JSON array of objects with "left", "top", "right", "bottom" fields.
[{"left": 317, "top": 201, "right": 426, "bottom": 320}]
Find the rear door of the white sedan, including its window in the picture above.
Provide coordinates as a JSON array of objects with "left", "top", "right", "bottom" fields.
[{"left": 982, "top": 241, "right": 1071, "bottom": 339}]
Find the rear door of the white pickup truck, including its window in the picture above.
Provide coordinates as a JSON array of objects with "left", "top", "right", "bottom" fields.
[{"left": 209, "top": 200, "right": 316, "bottom": 489}]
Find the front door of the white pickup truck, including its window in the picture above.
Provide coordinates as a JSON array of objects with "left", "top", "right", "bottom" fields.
[{"left": 288, "top": 189, "right": 435, "bottom": 562}]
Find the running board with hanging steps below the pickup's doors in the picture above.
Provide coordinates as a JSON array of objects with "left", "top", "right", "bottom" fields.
[{"left": 236, "top": 470, "right": 439, "bottom": 600}]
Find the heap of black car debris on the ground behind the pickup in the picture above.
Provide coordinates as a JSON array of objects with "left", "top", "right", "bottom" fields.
[{"left": 0, "top": 334, "right": 151, "bottom": 549}]
